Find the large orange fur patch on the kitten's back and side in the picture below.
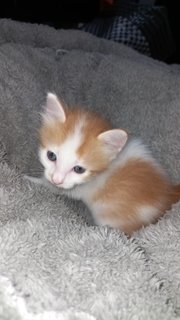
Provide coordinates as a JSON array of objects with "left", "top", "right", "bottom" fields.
[{"left": 93, "top": 159, "right": 171, "bottom": 234}]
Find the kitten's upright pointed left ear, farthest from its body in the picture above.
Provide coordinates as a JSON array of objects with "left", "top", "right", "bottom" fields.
[{"left": 42, "top": 92, "right": 66, "bottom": 123}]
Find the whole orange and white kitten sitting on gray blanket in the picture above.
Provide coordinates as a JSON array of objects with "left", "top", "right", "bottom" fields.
[{"left": 39, "top": 93, "right": 180, "bottom": 234}]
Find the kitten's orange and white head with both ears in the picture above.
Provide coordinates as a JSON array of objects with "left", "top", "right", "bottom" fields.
[{"left": 39, "top": 93, "right": 127, "bottom": 189}]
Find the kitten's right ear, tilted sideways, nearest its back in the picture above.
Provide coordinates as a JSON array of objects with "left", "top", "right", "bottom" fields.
[{"left": 98, "top": 129, "right": 128, "bottom": 159}]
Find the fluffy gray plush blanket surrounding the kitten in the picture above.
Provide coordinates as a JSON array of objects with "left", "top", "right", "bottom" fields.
[{"left": 0, "top": 20, "right": 180, "bottom": 320}]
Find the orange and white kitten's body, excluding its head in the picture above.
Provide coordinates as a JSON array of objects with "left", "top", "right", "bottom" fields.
[{"left": 68, "top": 140, "right": 180, "bottom": 234}]
